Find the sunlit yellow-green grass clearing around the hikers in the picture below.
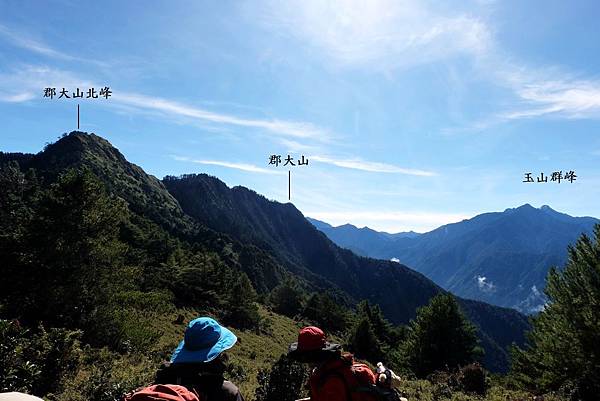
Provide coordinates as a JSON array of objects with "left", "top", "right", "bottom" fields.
[{"left": 54, "top": 306, "right": 566, "bottom": 401}]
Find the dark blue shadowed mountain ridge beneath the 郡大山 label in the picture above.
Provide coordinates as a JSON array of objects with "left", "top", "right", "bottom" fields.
[{"left": 163, "top": 174, "right": 527, "bottom": 370}]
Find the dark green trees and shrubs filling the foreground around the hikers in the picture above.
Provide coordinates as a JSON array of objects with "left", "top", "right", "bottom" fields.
[{"left": 0, "top": 154, "right": 600, "bottom": 401}]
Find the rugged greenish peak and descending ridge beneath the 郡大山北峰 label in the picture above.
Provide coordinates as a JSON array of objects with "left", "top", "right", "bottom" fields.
[{"left": 0, "top": 132, "right": 286, "bottom": 292}]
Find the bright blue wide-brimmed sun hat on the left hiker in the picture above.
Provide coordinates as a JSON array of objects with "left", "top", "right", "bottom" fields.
[{"left": 171, "top": 317, "right": 237, "bottom": 363}]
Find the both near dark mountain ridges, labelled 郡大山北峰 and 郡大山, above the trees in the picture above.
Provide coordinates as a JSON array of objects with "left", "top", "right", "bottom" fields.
[{"left": 0, "top": 132, "right": 528, "bottom": 371}]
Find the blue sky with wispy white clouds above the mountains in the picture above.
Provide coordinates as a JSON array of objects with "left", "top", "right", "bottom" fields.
[{"left": 0, "top": 0, "right": 600, "bottom": 232}]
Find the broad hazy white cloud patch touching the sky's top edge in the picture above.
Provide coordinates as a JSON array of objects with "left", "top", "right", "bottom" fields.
[{"left": 252, "top": 0, "right": 489, "bottom": 68}]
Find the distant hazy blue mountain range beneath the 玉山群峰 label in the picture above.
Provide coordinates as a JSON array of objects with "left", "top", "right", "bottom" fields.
[{"left": 310, "top": 204, "right": 600, "bottom": 313}]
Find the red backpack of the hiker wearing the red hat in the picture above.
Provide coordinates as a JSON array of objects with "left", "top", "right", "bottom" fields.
[{"left": 309, "top": 360, "right": 375, "bottom": 401}]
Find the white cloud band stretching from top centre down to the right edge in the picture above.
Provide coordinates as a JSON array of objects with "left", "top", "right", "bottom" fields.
[{"left": 252, "top": 0, "right": 600, "bottom": 123}]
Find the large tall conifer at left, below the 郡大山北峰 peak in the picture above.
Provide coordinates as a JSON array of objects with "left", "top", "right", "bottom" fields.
[{"left": 12, "top": 170, "right": 136, "bottom": 343}]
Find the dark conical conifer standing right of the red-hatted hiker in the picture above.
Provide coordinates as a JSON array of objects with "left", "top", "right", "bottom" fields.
[{"left": 404, "top": 294, "right": 482, "bottom": 377}]
